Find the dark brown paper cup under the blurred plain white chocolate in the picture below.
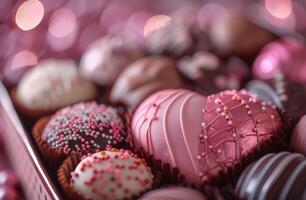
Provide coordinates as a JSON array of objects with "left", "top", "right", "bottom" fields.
[{"left": 11, "top": 87, "right": 56, "bottom": 123}]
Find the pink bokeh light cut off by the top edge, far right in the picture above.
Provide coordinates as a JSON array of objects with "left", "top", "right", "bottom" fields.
[{"left": 265, "top": 0, "right": 292, "bottom": 19}]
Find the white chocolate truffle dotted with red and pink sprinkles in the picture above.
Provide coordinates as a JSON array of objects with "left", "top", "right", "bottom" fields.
[{"left": 71, "top": 149, "right": 153, "bottom": 200}]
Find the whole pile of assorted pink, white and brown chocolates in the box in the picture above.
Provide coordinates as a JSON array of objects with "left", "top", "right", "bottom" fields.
[{"left": 0, "top": 1, "right": 306, "bottom": 200}]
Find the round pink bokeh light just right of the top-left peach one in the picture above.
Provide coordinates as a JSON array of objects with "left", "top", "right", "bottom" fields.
[{"left": 48, "top": 8, "right": 77, "bottom": 38}]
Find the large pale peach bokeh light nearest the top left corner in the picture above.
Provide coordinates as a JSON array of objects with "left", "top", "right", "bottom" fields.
[{"left": 15, "top": 0, "right": 44, "bottom": 31}]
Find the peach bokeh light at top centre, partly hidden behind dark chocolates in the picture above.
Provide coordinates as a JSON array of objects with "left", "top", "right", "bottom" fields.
[{"left": 143, "top": 15, "right": 172, "bottom": 36}]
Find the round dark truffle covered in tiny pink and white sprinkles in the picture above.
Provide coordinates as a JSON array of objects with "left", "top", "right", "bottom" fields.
[{"left": 41, "top": 102, "right": 125, "bottom": 154}]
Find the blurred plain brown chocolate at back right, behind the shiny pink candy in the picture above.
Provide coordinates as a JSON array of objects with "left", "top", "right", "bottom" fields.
[{"left": 209, "top": 11, "right": 275, "bottom": 57}]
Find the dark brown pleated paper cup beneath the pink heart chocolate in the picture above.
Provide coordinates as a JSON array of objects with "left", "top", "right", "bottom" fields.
[{"left": 126, "top": 108, "right": 292, "bottom": 188}]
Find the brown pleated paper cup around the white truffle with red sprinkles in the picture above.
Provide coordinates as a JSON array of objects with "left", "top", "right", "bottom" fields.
[{"left": 57, "top": 152, "right": 160, "bottom": 200}]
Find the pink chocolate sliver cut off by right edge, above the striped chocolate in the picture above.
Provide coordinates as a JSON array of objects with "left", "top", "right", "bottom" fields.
[{"left": 291, "top": 115, "right": 306, "bottom": 156}]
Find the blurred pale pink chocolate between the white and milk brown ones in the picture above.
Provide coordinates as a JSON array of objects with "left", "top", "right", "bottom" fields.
[{"left": 80, "top": 35, "right": 143, "bottom": 86}]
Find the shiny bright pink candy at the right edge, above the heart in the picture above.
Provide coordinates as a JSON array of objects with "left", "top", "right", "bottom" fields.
[{"left": 253, "top": 38, "right": 306, "bottom": 83}]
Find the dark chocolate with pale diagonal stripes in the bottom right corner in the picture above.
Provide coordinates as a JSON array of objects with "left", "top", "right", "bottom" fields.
[{"left": 236, "top": 152, "right": 306, "bottom": 200}]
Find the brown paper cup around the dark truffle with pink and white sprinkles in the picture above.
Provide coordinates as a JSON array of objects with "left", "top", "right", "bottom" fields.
[{"left": 32, "top": 116, "right": 70, "bottom": 168}]
